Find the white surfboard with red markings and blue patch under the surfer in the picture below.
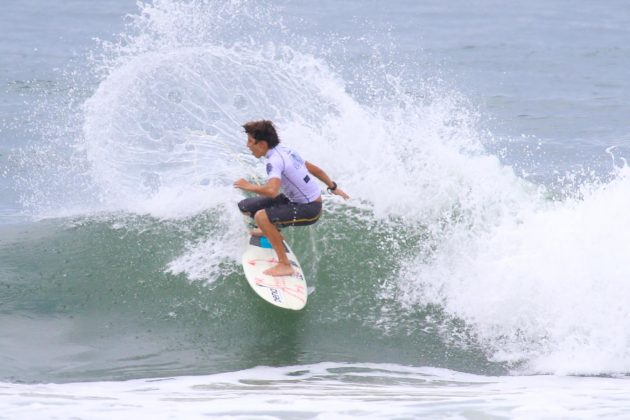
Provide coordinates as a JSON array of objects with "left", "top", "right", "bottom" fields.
[{"left": 242, "top": 236, "right": 308, "bottom": 311}]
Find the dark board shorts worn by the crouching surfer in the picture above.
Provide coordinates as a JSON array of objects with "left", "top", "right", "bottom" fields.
[{"left": 238, "top": 194, "right": 322, "bottom": 227}]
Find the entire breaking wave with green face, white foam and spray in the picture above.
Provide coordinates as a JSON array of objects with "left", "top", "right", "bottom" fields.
[{"left": 0, "top": 0, "right": 630, "bottom": 381}]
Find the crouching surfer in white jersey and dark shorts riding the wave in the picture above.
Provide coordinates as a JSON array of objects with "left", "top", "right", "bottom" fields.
[{"left": 234, "top": 120, "right": 350, "bottom": 276}]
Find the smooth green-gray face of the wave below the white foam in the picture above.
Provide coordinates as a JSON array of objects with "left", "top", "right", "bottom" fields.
[{"left": 0, "top": 213, "right": 504, "bottom": 382}]
